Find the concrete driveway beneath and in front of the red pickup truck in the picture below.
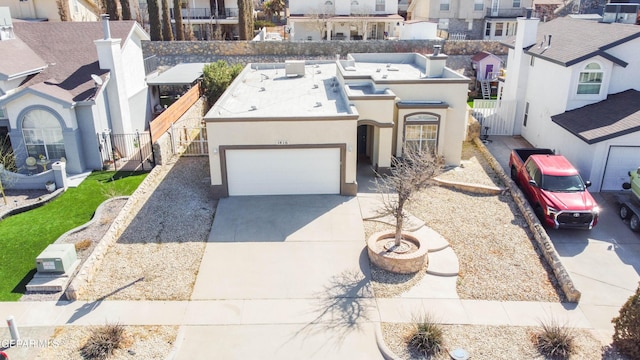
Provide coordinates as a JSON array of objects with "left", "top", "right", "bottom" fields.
[{"left": 486, "top": 136, "right": 640, "bottom": 333}]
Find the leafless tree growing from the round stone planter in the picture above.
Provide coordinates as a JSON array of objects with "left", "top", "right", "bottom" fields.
[{"left": 376, "top": 147, "right": 444, "bottom": 247}]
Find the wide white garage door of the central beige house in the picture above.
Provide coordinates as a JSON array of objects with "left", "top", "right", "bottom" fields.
[{"left": 226, "top": 148, "right": 340, "bottom": 196}]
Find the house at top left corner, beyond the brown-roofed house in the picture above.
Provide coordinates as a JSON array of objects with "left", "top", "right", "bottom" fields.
[{"left": 0, "top": 0, "right": 101, "bottom": 22}]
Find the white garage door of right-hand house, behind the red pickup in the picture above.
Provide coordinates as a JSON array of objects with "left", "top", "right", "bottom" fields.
[{"left": 601, "top": 146, "right": 640, "bottom": 191}]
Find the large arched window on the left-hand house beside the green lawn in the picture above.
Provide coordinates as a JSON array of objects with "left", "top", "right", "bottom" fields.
[{"left": 22, "top": 109, "right": 66, "bottom": 159}]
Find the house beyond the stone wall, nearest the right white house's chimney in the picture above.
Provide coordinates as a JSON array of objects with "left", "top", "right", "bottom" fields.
[{"left": 407, "top": 0, "right": 533, "bottom": 40}]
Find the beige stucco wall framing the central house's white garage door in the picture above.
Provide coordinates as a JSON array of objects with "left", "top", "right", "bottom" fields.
[{"left": 207, "top": 120, "right": 358, "bottom": 185}]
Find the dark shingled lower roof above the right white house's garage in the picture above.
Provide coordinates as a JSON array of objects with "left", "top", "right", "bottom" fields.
[{"left": 551, "top": 89, "right": 640, "bottom": 144}]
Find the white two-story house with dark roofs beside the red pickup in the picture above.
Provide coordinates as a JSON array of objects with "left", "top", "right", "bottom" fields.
[{"left": 499, "top": 14, "right": 640, "bottom": 191}]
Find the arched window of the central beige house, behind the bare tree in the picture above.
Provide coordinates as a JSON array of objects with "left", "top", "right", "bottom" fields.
[{"left": 404, "top": 114, "right": 440, "bottom": 152}]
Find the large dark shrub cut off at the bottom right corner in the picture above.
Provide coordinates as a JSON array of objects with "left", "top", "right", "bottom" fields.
[{"left": 611, "top": 284, "right": 640, "bottom": 359}]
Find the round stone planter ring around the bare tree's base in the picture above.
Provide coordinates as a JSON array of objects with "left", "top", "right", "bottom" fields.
[{"left": 367, "top": 231, "right": 429, "bottom": 274}]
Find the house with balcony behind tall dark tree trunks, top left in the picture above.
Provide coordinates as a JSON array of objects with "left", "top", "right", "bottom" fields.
[{"left": 138, "top": 0, "right": 239, "bottom": 40}]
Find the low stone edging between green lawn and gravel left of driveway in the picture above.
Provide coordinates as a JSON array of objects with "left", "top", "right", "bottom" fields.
[{"left": 65, "top": 166, "right": 171, "bottom": 300}]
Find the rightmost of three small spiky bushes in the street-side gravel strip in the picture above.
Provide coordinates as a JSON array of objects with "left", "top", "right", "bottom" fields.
[{"left": 534, "top": 320, "right": 575, "bottom": 360}]
